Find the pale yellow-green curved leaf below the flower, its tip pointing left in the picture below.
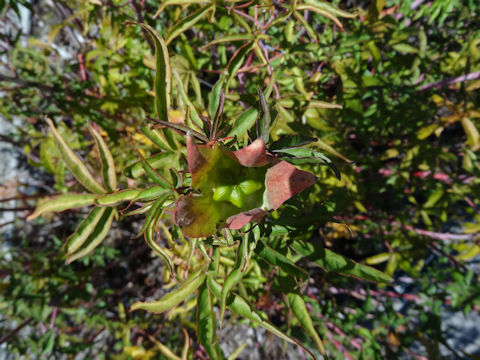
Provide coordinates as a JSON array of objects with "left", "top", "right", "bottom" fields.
[{"left": 130, "top": 269, "right": 205, "bottom": 313}]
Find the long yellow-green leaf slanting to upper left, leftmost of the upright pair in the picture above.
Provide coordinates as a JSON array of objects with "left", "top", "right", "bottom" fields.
[{"left": 47, "top": 118, "right": 107, "bottom": 194}]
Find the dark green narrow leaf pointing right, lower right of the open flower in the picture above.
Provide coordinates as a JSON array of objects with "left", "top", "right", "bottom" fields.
[{"left": 290, "top": 241, "right": 392, "bottom": 283}]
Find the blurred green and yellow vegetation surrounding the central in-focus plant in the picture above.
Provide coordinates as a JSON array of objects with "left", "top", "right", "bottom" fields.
[{"left": 0, "top": 0, "right": 480, "bottom": 359}]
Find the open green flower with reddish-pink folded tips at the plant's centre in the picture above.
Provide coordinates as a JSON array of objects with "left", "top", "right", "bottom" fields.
[{"left": 175, "top": 135, "right": 316, "bottom": 237}]
